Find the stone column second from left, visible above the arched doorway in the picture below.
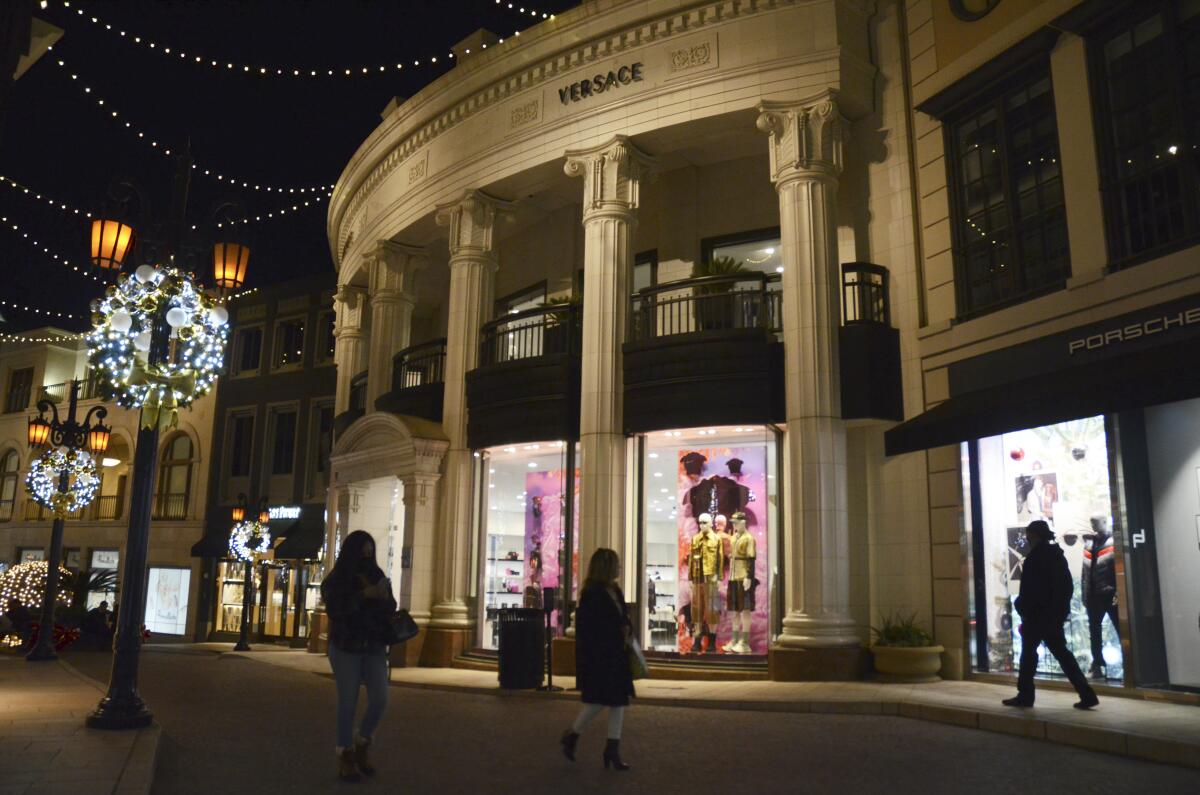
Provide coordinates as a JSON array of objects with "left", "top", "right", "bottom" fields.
[{"left": 367, "top": 240, "right": 428, "bottom": 412}]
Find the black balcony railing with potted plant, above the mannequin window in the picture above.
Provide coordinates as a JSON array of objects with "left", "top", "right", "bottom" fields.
[{"left": 629, "top": 273, "right": 782, "bottom": 342}]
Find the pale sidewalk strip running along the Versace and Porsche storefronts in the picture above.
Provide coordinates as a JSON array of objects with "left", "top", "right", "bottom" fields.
[{"left": 218, "top": 644, "right": 1200, "bottom": 769}]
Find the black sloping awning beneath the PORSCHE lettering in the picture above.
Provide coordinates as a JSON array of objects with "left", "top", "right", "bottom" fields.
[{"left": 883, "top": 340, "right": 1200, "bottom": 455}]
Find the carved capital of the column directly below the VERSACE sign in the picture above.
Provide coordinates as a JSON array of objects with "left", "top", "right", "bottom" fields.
[{"left": 563, "top": 136, "right": 658, "bottom": 222}]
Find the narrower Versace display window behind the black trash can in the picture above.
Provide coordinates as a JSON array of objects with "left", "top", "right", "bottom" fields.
[{"left": 479, "top": 442, "right": 580, "bottom": 648}]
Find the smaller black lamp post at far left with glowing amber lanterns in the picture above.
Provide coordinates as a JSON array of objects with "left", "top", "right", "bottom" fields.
[{"left": 25, "top": 381, "right": 113, "bottom": 663}]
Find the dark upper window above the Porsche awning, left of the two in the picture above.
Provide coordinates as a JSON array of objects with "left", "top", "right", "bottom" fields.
[{"left": 946, "top": 64, "right": 1070, "bottom": 317}]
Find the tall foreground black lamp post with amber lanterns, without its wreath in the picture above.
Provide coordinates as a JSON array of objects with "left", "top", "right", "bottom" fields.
[{"left": 86, "top": 154, "right": 250, "bottom": 729}]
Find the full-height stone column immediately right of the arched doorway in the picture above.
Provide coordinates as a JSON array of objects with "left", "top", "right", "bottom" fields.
[{"left": 430, "top": 191, "right": 510, "bottom": 638}]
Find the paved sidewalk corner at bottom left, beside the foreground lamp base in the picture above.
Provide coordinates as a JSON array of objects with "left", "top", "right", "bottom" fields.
[{"left": 0, "top": 653, "right": 160, "bottom": 795}]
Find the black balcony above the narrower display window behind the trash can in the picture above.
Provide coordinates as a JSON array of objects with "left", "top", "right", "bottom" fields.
[{"left": 467, "top": 304, "right": 583, "bottom": 448}]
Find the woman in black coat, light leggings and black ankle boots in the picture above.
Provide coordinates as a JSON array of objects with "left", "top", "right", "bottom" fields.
[{"left": 562, "top": 549, "right": 634, "bottom": 770}]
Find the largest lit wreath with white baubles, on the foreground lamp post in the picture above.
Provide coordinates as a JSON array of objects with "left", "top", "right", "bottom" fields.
[{"left": 88, "top": 265, "right": 229, "bottom": 429}]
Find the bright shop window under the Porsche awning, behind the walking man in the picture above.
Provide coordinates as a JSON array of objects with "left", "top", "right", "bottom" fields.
[{"left": 964, "top": 417, "right": 1124, "bottom": 683}]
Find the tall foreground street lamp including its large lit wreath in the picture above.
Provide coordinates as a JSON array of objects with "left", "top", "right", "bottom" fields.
[{"left": 85, "top": 153, "right": 248, "bottom": 729}]
